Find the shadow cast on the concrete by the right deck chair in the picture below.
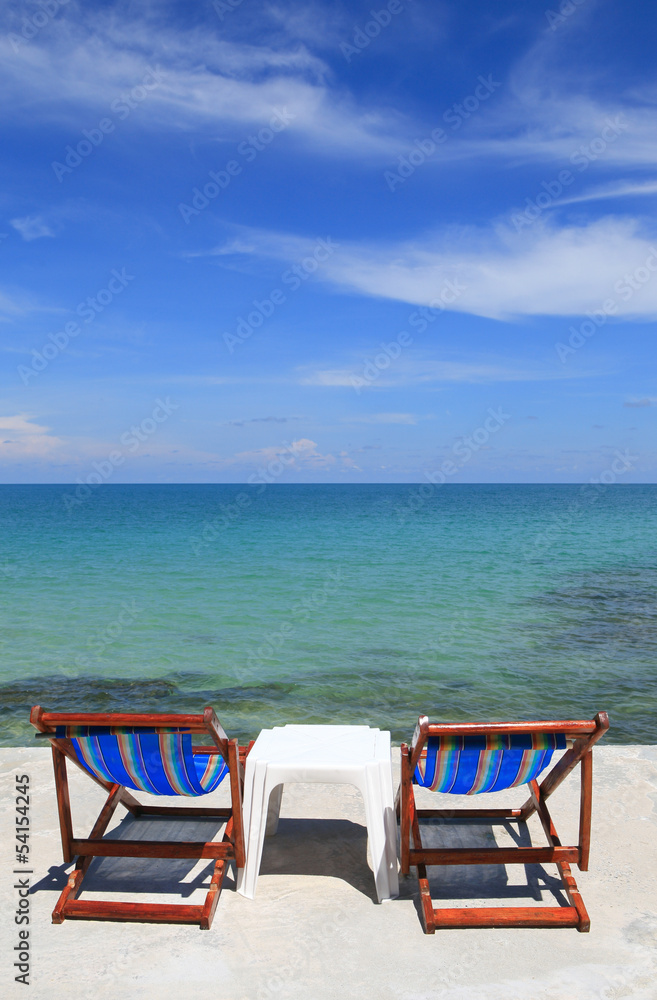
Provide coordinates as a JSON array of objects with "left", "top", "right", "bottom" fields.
[{"left": 401, "top": 819, "right": 570, "bottom": 912}]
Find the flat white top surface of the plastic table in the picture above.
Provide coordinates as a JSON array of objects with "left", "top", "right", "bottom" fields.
[{"left": 246, "top": 725, "right": 390, "bottom": 767}]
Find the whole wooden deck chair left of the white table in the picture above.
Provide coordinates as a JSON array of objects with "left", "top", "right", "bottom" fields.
[{"left": 30, "top": 705, "right": 248, "bottom": 930}]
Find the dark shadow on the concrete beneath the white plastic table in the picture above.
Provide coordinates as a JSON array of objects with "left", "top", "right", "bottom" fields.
[{"left": 260, "top": 819, "right": 377, "bottom": 903}]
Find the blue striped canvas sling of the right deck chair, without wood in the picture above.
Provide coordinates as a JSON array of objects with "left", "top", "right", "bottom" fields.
[{"left": 413, "top": 733, "right": 566, "bottom": 795}]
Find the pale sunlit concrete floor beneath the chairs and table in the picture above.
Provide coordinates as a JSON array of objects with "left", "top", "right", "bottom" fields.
[{"left": 0, "top": 746, "right": 657, "bottom": 1000}]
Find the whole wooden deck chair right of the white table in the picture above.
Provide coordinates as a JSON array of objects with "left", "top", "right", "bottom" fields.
[{"left": 397, "top": 712, "right": 609, "bottom": 934}]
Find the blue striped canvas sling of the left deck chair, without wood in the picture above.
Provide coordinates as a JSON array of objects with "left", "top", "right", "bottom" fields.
[{"left": 57, "top": 726, "right": 228, "bottom": 796}]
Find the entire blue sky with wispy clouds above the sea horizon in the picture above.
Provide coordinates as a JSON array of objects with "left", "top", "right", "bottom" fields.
[{"left": 0, "top": 0, "right": 657, "bottom": 483}]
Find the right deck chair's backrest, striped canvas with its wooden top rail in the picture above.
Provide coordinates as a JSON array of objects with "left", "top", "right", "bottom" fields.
[{"left": 411, "top": 716, "right": 596, "bottom": 795}]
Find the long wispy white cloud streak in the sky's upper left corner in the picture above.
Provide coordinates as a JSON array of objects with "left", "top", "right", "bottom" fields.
[{"left": 0, "top": 10, "right": 397, "bottom": 156}]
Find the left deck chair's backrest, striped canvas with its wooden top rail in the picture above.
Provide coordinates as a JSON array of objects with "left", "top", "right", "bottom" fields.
[{"left": 30, "top": 706, "right": 229, "bottom": 796}]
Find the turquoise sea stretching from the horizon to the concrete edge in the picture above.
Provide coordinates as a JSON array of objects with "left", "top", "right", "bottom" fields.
[{"left": 0, "top": 483, "right": 657, "bottom": 745}]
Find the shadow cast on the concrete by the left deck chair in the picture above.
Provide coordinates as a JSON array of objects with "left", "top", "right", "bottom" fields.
[{"left": 31, "top": 814, "right": 235, "bottom": 899}]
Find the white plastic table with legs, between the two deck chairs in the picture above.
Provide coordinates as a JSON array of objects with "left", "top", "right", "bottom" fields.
[{"left": 237, "top": 726, "right": 399, "bottom": 903}]
